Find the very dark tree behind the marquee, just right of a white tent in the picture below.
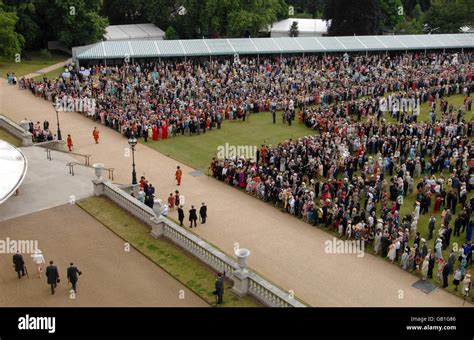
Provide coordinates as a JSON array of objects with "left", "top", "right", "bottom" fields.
[{"left": 323, "top": 0, "right": 381, "bottom": 36}]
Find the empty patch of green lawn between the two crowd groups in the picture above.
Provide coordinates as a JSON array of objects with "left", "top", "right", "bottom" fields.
[{"left": 144, "top": 112, "right": 312, "bottom": 174}]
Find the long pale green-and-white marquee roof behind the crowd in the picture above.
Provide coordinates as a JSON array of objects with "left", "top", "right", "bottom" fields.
[{"left": 73, "top": 33, "right": 474, "bottom": 63}]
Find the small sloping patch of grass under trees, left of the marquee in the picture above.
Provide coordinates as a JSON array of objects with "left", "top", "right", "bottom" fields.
[{"left": 0, "top": 51, "right": 69, "bottom": 78}]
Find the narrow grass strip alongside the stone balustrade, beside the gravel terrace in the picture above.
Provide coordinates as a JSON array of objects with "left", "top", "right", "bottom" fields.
[{"left": 77, "top": 196, "right": 261, "bottom": 307}]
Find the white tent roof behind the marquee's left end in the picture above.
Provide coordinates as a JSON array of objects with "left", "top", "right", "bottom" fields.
[{"left": 104, "top": 24, "right": 165, "bottom": 40}]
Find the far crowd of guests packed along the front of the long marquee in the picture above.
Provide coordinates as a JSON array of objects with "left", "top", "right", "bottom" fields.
[{"left": 19, "top": 52, "right": 472, "bottom": 140}]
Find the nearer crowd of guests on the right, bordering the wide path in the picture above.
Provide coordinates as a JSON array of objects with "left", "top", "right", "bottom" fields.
[{"left": 210, "top": 49, "right": 474, "bottom": 294}]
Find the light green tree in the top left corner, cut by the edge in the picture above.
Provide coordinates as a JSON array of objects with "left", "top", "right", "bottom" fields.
[{"left": 0, "top": 1, "right": 25, "bottom": 57}]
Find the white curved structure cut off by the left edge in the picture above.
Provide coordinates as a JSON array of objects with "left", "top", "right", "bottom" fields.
[{"left": 0, "top": 140, "right": 28, "bottom": 204}]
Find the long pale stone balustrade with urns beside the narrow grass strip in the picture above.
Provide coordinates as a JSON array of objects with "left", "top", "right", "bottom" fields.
[{"left": 93, "top": 178, "right": 306, "bottom": 307}]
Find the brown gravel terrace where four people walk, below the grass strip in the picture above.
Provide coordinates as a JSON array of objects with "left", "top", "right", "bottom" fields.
[{"left": 0, "top": 204, "right": 207, "bottom": 307}]
